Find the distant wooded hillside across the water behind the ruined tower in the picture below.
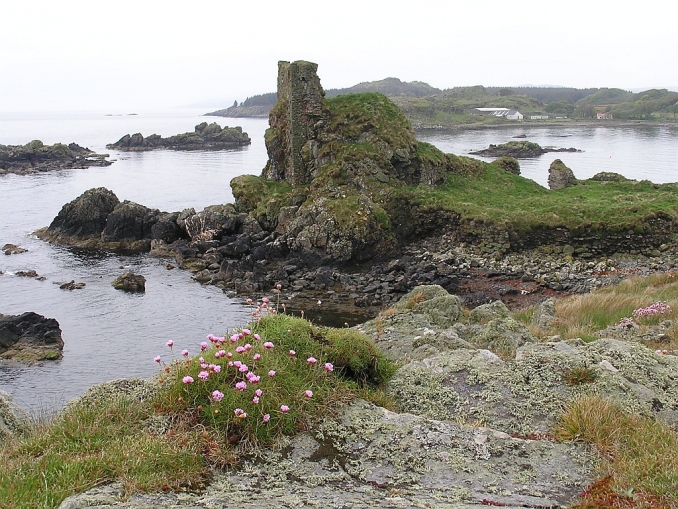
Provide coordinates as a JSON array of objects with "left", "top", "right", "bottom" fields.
[{"left": 206, "top": 78, "right": 678, "bottom": 127}]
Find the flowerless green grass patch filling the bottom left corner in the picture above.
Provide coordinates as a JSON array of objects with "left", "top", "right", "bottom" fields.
[{"left": 0, "top": 398, "right": 207, "bottom": 509}]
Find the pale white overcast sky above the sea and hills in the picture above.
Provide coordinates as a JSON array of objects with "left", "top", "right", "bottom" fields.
[{"left": 0, "top": 0, "right": 678, "bottom": 113}]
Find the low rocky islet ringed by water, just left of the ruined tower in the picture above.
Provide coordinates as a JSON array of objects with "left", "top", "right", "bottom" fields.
[{"left": 106, "top": 122, "right": 252, "bottom": 152}]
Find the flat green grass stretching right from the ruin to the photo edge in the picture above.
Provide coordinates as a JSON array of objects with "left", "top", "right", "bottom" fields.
[{"left": 406, "top": 165, "right": 678, "bottom": 232}]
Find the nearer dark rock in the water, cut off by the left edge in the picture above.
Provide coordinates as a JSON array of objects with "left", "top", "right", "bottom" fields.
[{"left": 0, "top": 312, "right": 64, "bottom": 362}]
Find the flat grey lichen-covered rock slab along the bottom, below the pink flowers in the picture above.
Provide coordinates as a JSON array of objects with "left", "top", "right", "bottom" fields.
[{"left": 60, "top": 400, "right": 594, "bottom": 509}]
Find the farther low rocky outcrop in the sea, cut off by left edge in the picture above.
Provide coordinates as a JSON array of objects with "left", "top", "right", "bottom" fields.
[{"left": 0, "top": 140, "right": 112, "bottom": 175}]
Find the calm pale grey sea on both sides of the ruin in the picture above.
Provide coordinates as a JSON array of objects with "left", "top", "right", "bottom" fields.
[{"left": 0, "top": 110, "right": 678, "bottom": 411}]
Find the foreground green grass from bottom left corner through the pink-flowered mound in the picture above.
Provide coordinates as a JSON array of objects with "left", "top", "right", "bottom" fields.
[{"left": 0, "top": 315, "right": 395, "bottom": 509}]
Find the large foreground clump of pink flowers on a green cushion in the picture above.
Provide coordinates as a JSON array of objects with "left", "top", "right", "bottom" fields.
[{"left": 154, "top": 299, "right": 334, "bottom": 436}]
